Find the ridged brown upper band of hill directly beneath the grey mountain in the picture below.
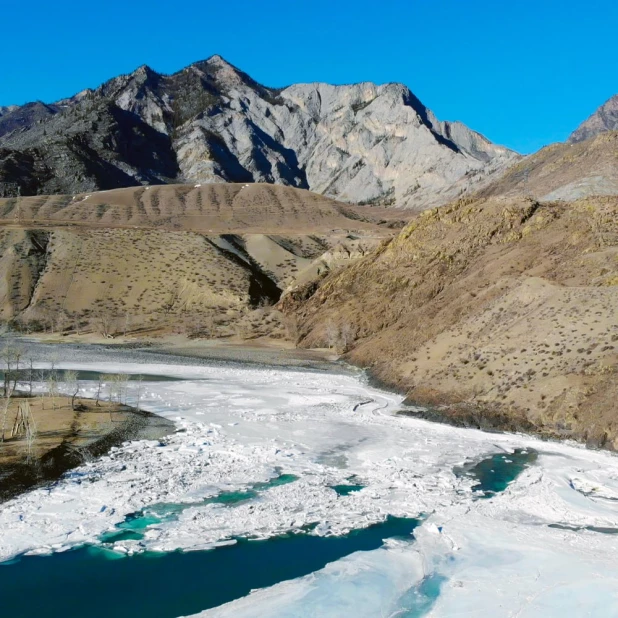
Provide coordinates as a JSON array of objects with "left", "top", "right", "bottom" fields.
[{"left": 0, "top": 183, "right": 401, "bottom": 234}]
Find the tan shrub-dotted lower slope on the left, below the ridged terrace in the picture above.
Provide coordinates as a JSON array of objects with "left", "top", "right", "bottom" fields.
[{"left": 0, "top": 228, "right": 278, "bottom": 334}]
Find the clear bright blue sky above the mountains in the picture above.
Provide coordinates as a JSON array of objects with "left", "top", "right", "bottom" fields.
[{"left": 0, "top": 0, "right": 618, "bottom": 152}]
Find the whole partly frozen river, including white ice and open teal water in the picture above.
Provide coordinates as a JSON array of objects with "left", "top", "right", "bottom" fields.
[{"left": 0, "top": 344, "right": 618, "bottom": 618}]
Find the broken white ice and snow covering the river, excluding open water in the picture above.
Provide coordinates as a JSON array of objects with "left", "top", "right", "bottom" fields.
[{"left": 0, "top": 362, "right": 618, "bottom": 618}]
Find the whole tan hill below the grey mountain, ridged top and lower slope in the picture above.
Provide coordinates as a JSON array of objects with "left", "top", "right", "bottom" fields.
[{"left": 0, "top": 184, "right": 393, "bottom": 335}]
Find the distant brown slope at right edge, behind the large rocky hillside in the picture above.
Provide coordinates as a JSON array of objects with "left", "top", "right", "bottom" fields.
[{"left": 479, "top": 131, "right": 618, "bottom": 201}]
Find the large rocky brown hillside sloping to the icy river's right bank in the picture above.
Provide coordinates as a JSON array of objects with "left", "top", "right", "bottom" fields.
[{"left": 280, "top": 197, "right": 618, "bottom": 448}]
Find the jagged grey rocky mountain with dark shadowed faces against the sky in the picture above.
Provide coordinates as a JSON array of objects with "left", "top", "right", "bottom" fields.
[{"left": 0, "top": 56, "right": 518, "bottom": 210}]
